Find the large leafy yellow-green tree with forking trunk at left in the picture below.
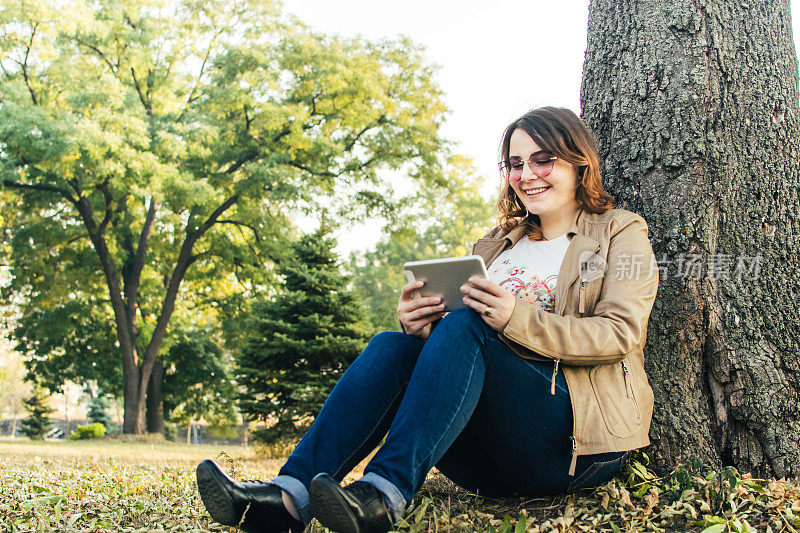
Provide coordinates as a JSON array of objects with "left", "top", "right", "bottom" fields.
[{"left": 0, "top": 0, "right": 444, "bottom": 433}]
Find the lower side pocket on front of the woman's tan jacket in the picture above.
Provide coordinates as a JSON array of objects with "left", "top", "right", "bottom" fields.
[{"left": 589, "top": 360, "right": 642, "bottom": 439}]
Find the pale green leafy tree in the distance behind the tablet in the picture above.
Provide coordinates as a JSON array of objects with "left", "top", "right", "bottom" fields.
[{"left": 350, "top": 156, "right": 496, "bottom": 331}]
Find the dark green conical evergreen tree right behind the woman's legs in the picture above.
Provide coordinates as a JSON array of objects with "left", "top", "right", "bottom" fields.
[{"left": 238, "top": 230, "right": 369, "bottom": 443}]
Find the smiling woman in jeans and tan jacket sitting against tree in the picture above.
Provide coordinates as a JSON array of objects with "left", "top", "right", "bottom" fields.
[{"left": 197, "top": 107, "right": 658, "bottom": 532}]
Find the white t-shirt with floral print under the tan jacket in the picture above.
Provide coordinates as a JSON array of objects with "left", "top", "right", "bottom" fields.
[{"left": 489, "top": 233, "right": 569, "bottom": 313}]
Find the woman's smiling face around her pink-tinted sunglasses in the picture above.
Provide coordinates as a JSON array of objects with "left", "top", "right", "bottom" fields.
[{"left": 508, "top": 128, "right": 578, "bottom": 216}]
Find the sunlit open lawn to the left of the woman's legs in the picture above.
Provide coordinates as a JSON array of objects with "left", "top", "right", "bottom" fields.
[{"left": 0, "top": 439, "right": 388, "bottom": 532}]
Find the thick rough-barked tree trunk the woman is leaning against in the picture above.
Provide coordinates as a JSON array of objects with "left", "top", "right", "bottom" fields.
[{"left": 581, "top": 0, "right": 800, "bottom": 477}]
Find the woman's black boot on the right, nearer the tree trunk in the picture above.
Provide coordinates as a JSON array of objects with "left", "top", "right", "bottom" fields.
[{"left": 308, "top": 474, "right": 393, "bottom": 533}]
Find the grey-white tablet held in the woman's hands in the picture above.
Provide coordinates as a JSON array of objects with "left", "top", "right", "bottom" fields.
[{"left": 403, "top": 255, "right": 488, "bottom": 311}]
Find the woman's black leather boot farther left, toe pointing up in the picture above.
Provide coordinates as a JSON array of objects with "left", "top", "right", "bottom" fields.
[{"left": 197, "top": 459, "right": 305, "bottom": 533}]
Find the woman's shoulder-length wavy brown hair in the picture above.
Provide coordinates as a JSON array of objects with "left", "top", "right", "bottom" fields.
[{"left": 497, "top": 107, "right": 614, "bottom": 241}]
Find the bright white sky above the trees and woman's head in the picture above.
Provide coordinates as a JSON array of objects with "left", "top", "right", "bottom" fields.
[{"left": 285, "top": 0, "right": 800, "bottom": 253}]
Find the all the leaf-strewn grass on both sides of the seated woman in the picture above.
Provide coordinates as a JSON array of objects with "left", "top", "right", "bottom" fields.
[{"left": 0, "top": 440, "right": 800, "bottom": 533}]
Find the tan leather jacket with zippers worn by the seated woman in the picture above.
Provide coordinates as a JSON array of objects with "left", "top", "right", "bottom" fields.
[{"left": 473, "top": 209, "right": 659, "bottom": 475}]
